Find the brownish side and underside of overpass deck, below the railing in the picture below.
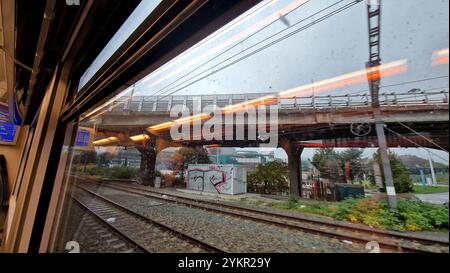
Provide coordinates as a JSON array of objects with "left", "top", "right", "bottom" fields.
[{"left": 89, "top": 104, "right": 449, "bottom": 150}]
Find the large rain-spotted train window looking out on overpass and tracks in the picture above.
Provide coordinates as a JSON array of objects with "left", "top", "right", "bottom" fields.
[{"left": 52, "top": 0, "right": 449, "bottom": 252}]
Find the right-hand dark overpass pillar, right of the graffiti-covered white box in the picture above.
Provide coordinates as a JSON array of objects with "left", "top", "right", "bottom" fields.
[{"left": 281, "top": 140, "right": 303, "bottom": 197}]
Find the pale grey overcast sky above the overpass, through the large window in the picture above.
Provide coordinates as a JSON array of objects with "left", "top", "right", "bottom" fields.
[{"left": 136, "top": 0, "right": 449, "bottom": 95}]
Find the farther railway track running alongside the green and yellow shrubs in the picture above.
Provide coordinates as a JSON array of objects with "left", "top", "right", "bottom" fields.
[{"left": 89, "top": 182, "right": 449, "bottom": 252}]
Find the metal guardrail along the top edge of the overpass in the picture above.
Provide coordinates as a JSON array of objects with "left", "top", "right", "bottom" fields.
[{"left": 107, "top": 90, "right": 449, "bottom": 112}]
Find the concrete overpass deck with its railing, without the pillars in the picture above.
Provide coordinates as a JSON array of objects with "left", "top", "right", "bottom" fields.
[{"left": 92, "top": 91, "right": 449, "bottom": 150}]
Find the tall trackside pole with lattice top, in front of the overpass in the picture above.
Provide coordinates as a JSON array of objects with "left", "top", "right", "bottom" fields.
[{"left": 366, "top": 0, "right": 397, "bottom": 211}]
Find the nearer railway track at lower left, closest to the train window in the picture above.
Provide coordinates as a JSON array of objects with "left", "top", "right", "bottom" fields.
[{"left": 71, "top": 186, "right": 223, "bottom": 253}]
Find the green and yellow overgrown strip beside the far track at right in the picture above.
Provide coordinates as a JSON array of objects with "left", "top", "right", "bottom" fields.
[{"left": 270, "top": 198, "right": 449, "bottom": 231}]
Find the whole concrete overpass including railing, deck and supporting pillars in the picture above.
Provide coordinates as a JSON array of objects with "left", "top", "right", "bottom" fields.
[{"left": 83, "top": 90, "right": 449, "bottom": 191}]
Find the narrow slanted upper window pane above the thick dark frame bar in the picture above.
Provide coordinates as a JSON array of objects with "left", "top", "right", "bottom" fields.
[{"left": 78, "top": 0, "right": 161, "bottom": 90}]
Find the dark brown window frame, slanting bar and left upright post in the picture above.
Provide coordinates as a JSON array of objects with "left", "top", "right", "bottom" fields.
[{"left": 39, "top": 0, "right": 262, "bottom": 252}]
